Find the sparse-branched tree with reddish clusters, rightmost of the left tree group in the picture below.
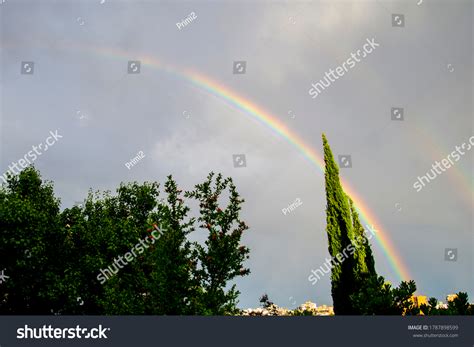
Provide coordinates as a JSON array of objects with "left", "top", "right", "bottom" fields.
[{"left": 185, "top": 173, "right": 250, "bottom": 315}]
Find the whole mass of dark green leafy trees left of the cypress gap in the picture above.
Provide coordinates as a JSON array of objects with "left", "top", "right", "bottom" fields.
[{"left": 0, "top": 168, "right": 249, "bottom": 315}]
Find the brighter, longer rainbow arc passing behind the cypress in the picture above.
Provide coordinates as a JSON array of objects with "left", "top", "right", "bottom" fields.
[{"left": 74, "top": 44, "right": 411, "bottom": 281}]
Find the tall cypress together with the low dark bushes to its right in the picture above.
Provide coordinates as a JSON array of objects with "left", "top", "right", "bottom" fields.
[{"left": 322, "top": 134, "right": 472, "bottom": 315}]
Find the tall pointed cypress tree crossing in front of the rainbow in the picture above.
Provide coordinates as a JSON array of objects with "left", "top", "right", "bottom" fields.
[{"left": 322, "top": 134, "right": 375, "bottom": 314}]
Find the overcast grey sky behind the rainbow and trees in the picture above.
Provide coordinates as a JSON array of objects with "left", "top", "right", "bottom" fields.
[{"left": 0, "top": 0, "right": 474, "bottom": 308}]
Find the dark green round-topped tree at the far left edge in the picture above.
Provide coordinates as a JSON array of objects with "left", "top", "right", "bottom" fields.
[{"left": 0, "top": 168, "right": 65, "bottom": 314}]
